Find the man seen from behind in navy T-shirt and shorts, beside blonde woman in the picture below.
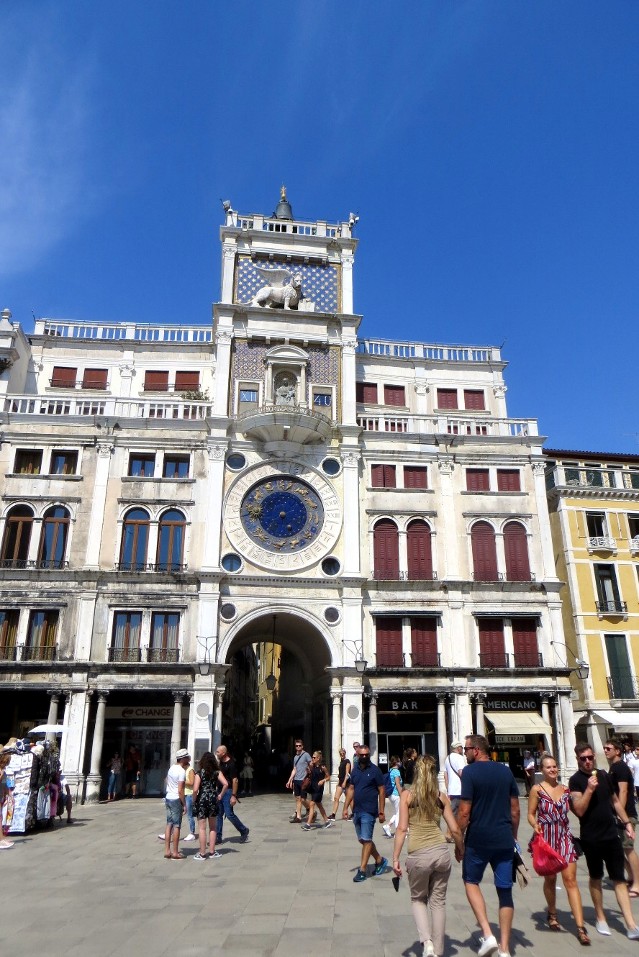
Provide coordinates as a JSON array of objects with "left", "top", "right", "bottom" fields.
[{"left": 455, "top": 734, "right": 520, "bottom": 957}]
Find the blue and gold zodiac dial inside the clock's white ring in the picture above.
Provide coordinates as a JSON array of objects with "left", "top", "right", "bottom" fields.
[{"left": 240, "top": 475, "right": 324, "bottom": 554}]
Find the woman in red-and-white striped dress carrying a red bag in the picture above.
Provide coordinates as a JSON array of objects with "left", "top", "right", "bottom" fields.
[{"left": 528, "top": 754, "right": 590, "bottom": 946}]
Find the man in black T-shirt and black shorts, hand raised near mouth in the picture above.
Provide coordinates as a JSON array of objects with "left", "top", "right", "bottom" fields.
[{"left": 568, "top": 742, "right": 639, "bottom": 940}]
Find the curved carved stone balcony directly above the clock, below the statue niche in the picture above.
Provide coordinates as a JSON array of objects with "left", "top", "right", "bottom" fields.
[{"left": 236, "top": 405, "right": 333, "bottom": 445}]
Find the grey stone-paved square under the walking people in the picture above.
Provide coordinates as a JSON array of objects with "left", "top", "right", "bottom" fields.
[{"left": 0, "top": 795, "right": 639, "bottom": 957}]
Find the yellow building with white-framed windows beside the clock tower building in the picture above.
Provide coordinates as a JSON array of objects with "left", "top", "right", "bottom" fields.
[{"left": 545, "top": 449, "right": 639, "bottom": 758}]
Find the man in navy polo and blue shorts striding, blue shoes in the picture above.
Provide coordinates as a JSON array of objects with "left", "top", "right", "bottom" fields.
[{"left": 348, "top": 744, "right": 388, "bottom": 884}]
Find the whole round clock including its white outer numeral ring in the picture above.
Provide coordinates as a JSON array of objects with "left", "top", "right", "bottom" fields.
[{"left": 224, "top": 462, "right": 342, "bottom": 571}]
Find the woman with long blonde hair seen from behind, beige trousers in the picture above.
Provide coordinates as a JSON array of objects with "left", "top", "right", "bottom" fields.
[{"left": 393, "top": 754, "right": 463, "bottom": 957}]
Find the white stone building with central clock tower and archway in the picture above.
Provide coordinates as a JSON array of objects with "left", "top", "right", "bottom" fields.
[{"left": 0, "top": 189, "right": 574, "bottom": 799}]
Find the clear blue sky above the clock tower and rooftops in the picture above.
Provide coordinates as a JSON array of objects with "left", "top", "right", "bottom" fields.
[{"left": 0, "top": 0, "right": 639, "bottom": 454}]
